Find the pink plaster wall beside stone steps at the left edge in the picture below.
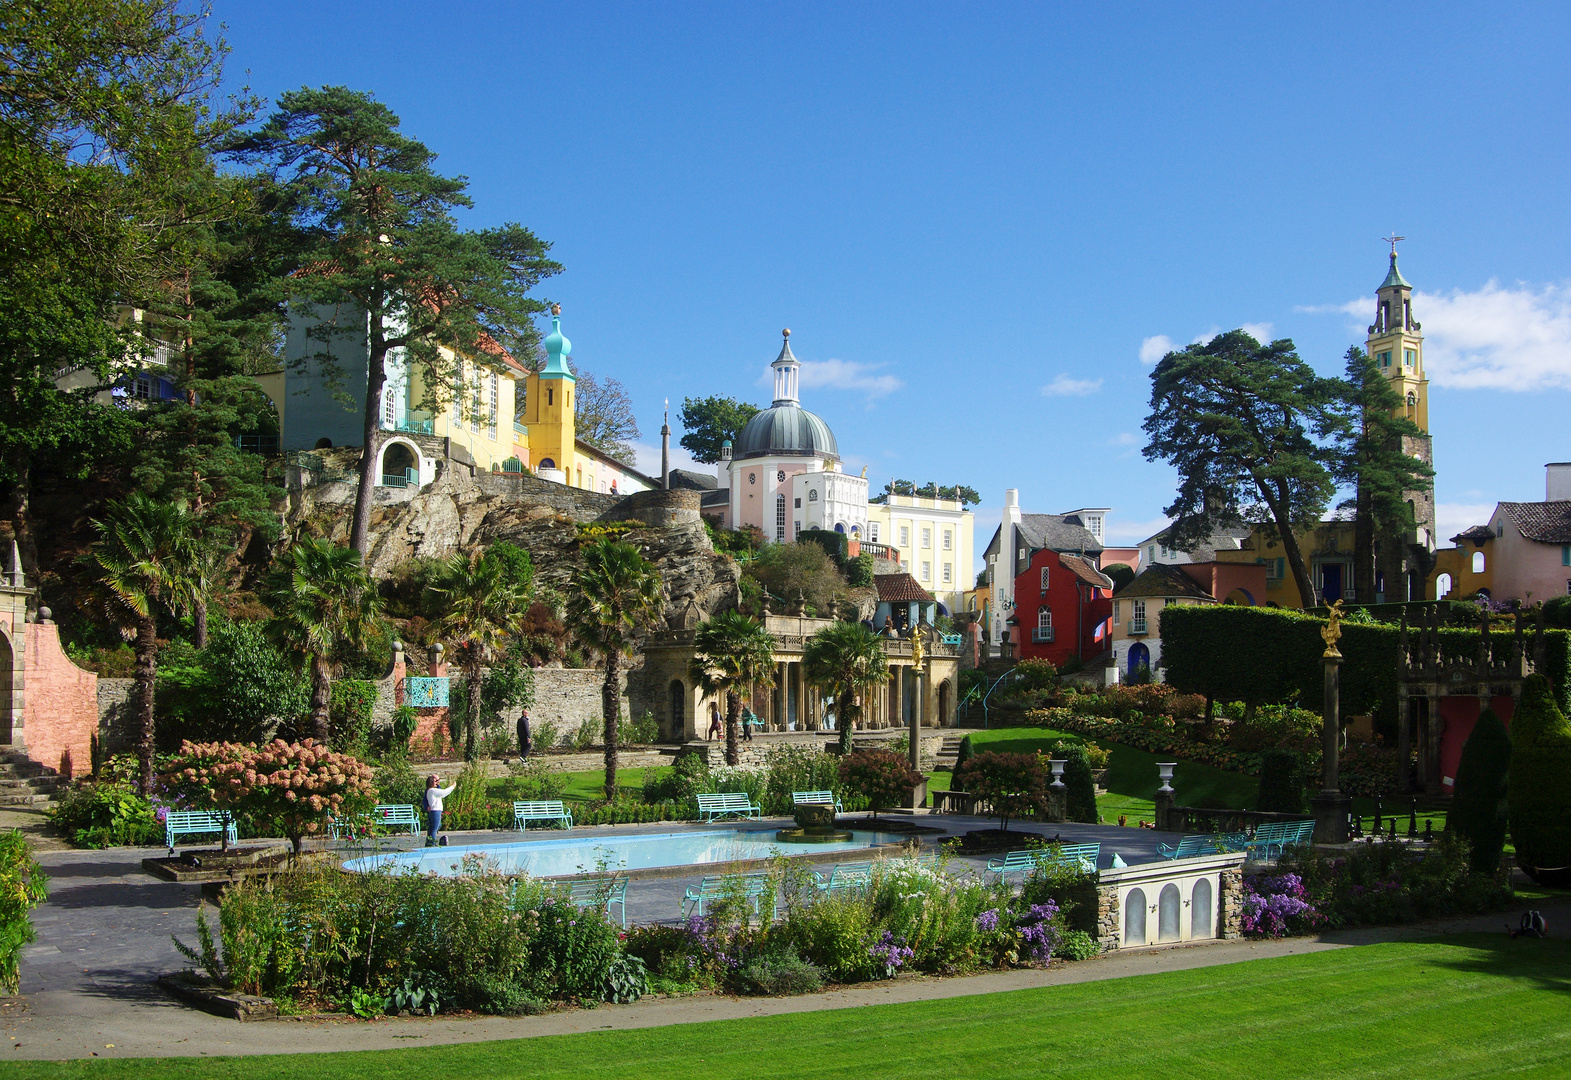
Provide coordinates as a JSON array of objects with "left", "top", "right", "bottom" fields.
[{"left": 22, "top": 623, "right": 97, "bottom": 777}]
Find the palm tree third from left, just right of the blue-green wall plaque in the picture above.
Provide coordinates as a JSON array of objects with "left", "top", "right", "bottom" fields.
[{"left": 430, "top": 555, "right": 529, "bottom": 762}]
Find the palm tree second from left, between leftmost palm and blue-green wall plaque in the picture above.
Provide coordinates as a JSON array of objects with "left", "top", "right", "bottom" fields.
[{"left": 265, "top": 538, "right": 382, "bottom": 745}]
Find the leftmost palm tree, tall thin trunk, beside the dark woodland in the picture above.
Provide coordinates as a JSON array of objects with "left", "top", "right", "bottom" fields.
[{"left": 91, "top": 492, "right": 195, "bottom": 794}]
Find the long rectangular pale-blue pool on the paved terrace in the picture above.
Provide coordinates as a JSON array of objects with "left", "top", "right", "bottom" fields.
[{"left": 344, "top": 828, "right": 906, "bottom": 877}]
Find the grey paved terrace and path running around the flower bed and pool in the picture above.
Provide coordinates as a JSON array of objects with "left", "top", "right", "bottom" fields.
[{"left": 0, "top": 817, "right": 1539, "bottom": 1058}]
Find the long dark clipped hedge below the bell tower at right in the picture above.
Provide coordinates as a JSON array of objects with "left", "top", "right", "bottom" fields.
[{"left": 1161, "top": 604, "right": 1571, "bottom": 723}]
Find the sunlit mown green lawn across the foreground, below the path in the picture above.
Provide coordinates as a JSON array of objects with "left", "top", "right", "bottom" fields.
[{"left": 15, "top": 934, "right": 1571, "bottom": 1080}]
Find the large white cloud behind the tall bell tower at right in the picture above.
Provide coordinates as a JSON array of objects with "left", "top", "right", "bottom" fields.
[{"left": 1338, "top": 281, "right": 1571, "bottom": 390}]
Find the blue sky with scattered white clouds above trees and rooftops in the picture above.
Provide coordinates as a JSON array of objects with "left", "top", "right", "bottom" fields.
[{"left": 215, "top": 0, "right": 1571, "bottom": 565}]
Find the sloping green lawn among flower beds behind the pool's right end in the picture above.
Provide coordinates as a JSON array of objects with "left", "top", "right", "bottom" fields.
[{"left": 927, "top": 728, "right": 1445, "bottom": 835}]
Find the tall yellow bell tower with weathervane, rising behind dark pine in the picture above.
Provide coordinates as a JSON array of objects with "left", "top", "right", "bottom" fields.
[{"left": 1359, "top": 233, "right": 1436, "bottom": 602}]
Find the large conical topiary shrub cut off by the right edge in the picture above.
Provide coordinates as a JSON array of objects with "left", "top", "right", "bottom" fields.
[{"left": 1508, "top": 674, "right": 1571, "bottom": 888}]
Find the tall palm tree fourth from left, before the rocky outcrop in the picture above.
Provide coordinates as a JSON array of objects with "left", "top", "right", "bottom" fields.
[{"left": 567, "top": 539, "right": 665, "bottom": 799}]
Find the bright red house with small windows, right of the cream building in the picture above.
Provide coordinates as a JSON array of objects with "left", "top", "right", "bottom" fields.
[{"left": 1009, "top": 547, "right": 1112, "bottom": 667}]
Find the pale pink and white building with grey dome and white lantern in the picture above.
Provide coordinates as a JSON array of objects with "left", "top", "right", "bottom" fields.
[{"left": 705, "top": 330, "right": 867, "bottom": 541}]
